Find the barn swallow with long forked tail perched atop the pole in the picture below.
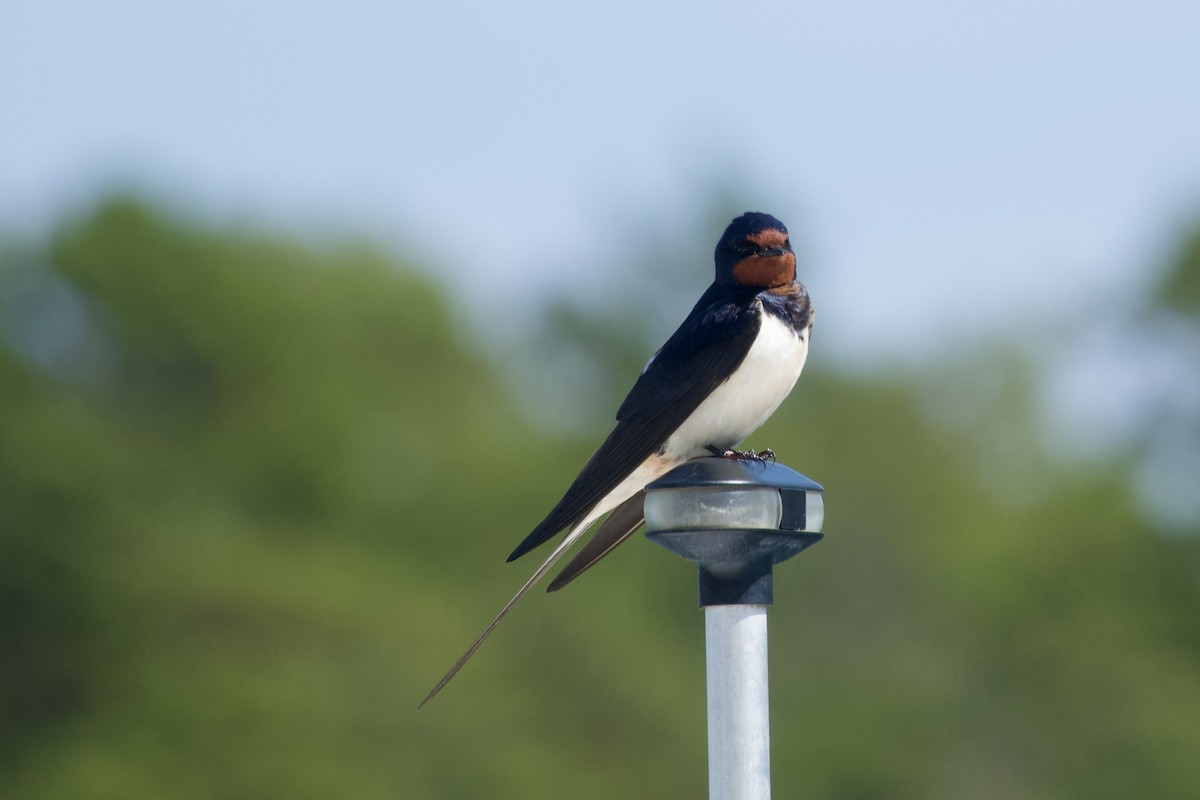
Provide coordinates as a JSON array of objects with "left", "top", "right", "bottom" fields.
[{"left": 421, "top": 212, "right": 812, "bottom": 705}]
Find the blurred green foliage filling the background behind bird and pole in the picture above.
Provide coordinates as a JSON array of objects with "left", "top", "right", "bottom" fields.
[{"left": 0, "top": 198, "right": 1200, "bottom": 799}]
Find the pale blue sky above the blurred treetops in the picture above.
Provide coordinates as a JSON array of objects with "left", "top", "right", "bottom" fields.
[{"left": 0, "top": 0, "right": 1200, "bottom": 355}]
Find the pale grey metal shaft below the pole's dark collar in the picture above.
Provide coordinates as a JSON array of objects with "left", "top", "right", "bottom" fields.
[{"left": 704, "top": 606, "right": 770, "bottom": 800}]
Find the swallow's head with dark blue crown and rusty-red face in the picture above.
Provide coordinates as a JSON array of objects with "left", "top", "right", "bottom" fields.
[{"left": 714, "top": 211, "right": 796, "bottom": 291}]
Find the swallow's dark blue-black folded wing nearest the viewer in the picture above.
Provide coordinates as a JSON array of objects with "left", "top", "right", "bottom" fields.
[{"left": 509, "top": 284, "right": 762, "bottom": 561}]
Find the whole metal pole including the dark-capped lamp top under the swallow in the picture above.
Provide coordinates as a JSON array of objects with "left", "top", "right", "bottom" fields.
[{"left": 644, "top": 458, "right": 824, "bottom": 800}]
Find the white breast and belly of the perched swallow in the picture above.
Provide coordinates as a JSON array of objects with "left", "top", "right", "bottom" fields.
[{"left": 664, "top": 312, "right": 809, "bottom": 459}]
